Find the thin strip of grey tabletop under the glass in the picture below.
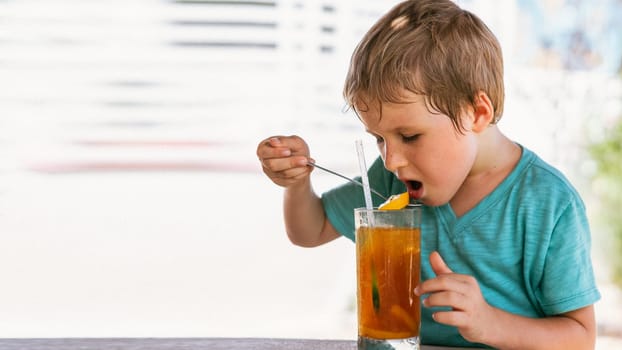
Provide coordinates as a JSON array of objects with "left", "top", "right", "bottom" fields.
[{"left": 0, "top": 338, "right": 476, "bottom": 350}]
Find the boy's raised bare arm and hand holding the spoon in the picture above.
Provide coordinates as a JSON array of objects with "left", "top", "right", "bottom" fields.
[{"left": 257, "top": 136, "right": 340, "bottom": 247}]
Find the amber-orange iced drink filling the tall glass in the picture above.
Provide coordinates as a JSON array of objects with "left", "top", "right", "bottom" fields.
[{"left": 356, "top": 227, "right": 421, "bottom": 339}]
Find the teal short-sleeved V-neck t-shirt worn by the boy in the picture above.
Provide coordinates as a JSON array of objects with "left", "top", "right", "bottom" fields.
[{"left": 322, "top": 147, "right": 600, "bottom": 346}]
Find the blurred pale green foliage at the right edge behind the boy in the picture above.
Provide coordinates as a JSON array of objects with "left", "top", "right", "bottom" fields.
[{"left": 590, "top": 118, "right": 622, "bottom": 286}]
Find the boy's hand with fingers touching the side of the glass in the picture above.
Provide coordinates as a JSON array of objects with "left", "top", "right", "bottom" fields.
[{"left": 415, "top": 252, "right": 496, "bottom": 342}]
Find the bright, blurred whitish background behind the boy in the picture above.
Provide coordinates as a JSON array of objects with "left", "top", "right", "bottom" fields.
[{"left": 0, "top": 0, "right": 622, "bottom": 349}]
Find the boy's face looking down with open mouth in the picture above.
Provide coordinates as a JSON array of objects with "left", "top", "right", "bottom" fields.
[{"left": 357, "top": 93, "right": 478, "bottom": 206}]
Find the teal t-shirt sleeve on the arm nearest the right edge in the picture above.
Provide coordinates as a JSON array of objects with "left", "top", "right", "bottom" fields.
[{"left": 536, "top": 197, "right": 600, "bottom": 315}]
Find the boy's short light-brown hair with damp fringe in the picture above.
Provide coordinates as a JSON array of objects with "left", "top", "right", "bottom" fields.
[{"left": 343, "top": 0, "right": 504, "bottom": 130}]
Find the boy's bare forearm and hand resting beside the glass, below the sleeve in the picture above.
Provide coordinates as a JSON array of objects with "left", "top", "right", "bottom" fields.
[{"left": 416, "top": 252, "right": 596, "bottom": 350}]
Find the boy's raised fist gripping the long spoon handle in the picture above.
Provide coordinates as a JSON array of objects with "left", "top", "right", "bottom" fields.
[{"left": 257, "top": 136, "right": 313, "bottom": 187}]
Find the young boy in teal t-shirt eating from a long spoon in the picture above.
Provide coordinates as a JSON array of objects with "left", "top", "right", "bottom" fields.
[{"left": 257, "top": 0, "right": 600, "bottom": 350}]
